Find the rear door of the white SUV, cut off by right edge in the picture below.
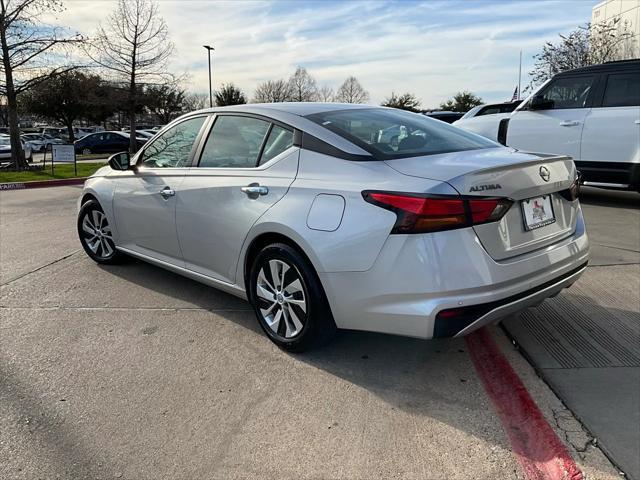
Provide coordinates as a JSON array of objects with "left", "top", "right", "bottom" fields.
[{"left": 577, "top": 71, "right": 640, "bottom": 184}]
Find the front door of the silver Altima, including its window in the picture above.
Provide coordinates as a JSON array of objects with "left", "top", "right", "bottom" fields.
[{"left": 113, "top": 115, "right": 208, "bottom": 266}]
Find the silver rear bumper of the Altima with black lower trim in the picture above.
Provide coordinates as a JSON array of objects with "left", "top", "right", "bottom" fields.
[{"left": 320, "top": 211, "right": 589, "bottom": 338}]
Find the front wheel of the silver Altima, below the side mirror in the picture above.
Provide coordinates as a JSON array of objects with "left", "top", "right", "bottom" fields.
[{"left": 78, "top": 200, "right": 125, "bottom": 265}]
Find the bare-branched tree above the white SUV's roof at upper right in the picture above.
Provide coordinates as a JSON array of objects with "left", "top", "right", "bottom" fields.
[{"left": 527, "top": 18, "right": 640, "bottom": 89}]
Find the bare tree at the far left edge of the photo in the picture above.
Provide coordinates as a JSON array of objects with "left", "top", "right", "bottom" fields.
[{"left": 0, "top": 0, "right": 82, "bottom": 170}]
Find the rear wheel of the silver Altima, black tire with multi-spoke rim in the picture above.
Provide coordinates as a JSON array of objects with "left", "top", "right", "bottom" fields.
[{"left": 248, "top": 243, "right": 337, "bottom": 352}]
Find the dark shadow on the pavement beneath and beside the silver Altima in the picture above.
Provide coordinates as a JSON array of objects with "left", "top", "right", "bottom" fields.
[{"left": 99, "top": 259, "right": 510, "bottom": 449}]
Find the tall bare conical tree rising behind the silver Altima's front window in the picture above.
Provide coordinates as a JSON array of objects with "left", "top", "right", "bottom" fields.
[{"left": 87, "top": 0, "right": 173, "bottom": 153}]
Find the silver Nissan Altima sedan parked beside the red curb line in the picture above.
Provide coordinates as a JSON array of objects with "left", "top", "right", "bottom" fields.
[{"left": 78, "top": 103, "right": 589, "bottom": 351}]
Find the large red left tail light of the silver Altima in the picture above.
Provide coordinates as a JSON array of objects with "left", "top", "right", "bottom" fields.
[{"left": 362, "top": 191, "right": 513, "bottom": 233}]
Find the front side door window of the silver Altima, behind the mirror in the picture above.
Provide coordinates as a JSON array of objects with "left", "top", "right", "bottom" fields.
[{"left": 140, "top": 117, "right": 206, "bottom": 168}]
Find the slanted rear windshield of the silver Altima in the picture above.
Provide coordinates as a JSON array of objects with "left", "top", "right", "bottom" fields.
[{"left": 307, "top": 108, "right": 501, "bottom": 160}]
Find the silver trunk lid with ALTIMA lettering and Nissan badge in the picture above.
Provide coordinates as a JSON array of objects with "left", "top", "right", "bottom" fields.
[{"left": 386, "top": 148, "right": 579, "bottom": 260}]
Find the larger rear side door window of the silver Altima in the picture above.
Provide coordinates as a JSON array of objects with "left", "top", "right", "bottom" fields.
[{"left": 199, "top": 115, "right": 270, "bottom": 168}]
